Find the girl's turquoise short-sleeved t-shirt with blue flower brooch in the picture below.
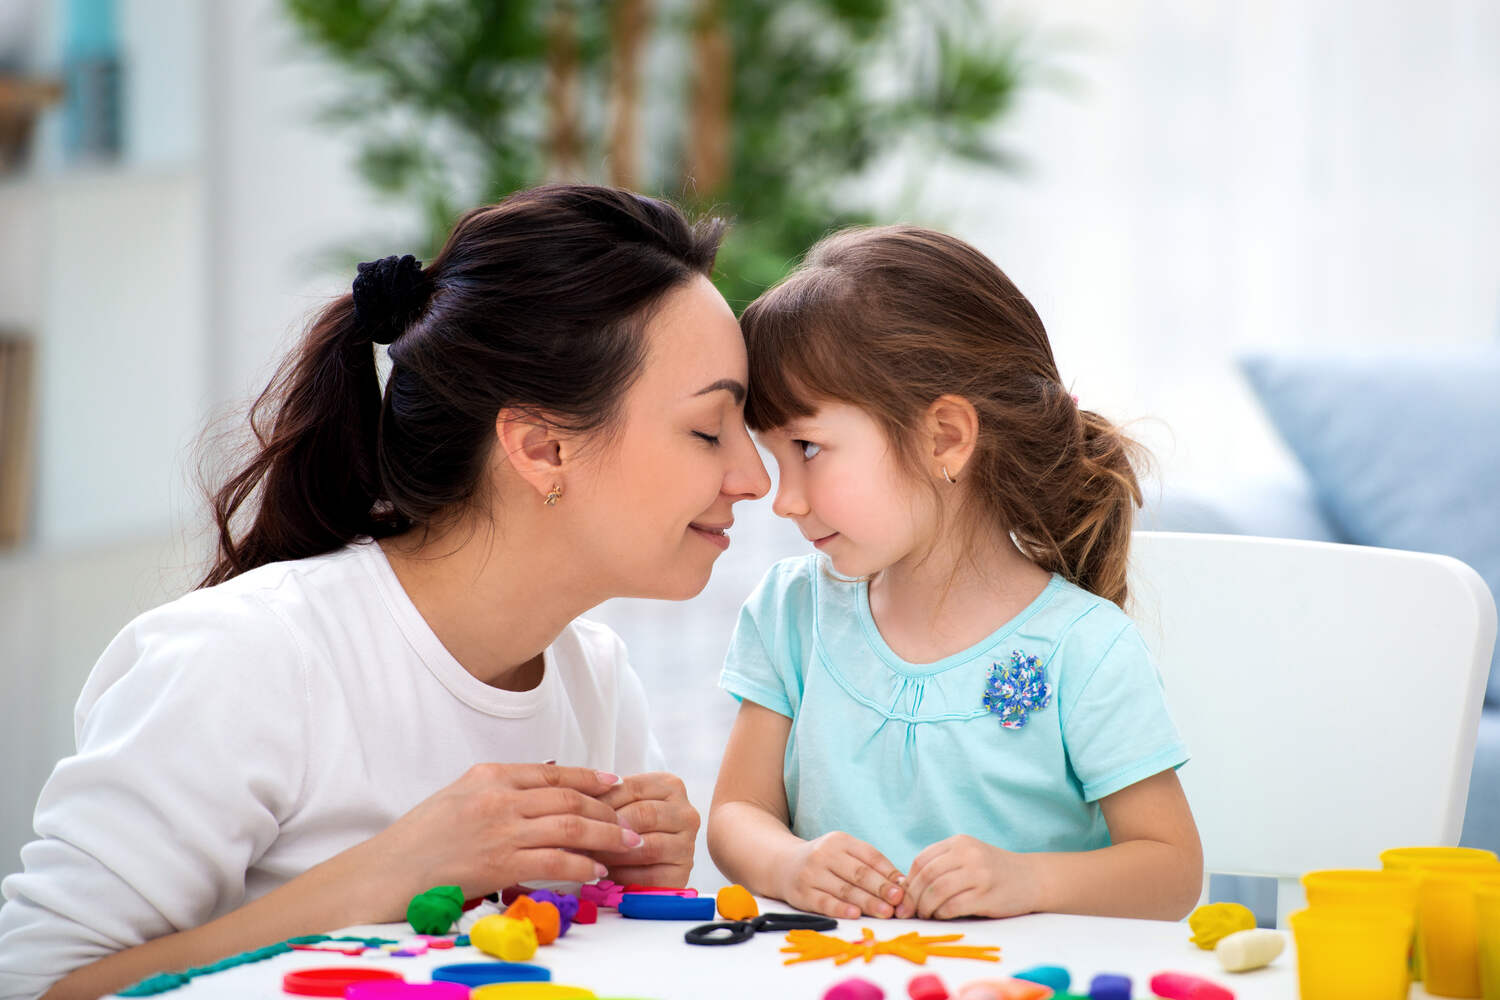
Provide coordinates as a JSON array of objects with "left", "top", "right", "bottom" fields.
[{"left": 719, "top": 553, "right": 1188, "bottom": 871}]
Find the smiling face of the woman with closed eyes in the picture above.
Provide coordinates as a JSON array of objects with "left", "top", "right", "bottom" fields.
[{"left": 564, "top": 276, "right": 771, "bottom": 600}]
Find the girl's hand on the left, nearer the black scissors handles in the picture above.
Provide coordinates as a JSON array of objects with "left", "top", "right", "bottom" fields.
[{"left": 776, "top": 831, "right": 903, "bottom": 921}]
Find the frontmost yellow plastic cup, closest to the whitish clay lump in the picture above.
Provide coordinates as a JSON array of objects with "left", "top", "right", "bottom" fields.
[{"left": 1289, "top": 906, "right": 1412, "bottom": 1000}]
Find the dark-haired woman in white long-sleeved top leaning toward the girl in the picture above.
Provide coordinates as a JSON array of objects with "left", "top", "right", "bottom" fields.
[{"left": 0, "top": 186, "right": 770, "bottom": 999}]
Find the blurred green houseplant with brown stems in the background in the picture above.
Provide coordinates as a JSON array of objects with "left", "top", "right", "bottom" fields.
[{"left": 284, "top": 0, "right": 1026, "bottom": 306}]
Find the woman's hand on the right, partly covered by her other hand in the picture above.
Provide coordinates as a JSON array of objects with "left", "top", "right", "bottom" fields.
[{"left": 591, "top": 774, "right": 702, "bottom": 886}]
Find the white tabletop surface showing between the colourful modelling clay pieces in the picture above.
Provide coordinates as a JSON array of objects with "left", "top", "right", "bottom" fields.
[{"left": 108, "top": 900, "right": 1326, "bottom": 1000}]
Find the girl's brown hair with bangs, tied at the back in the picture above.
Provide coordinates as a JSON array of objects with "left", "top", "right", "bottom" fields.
[{"left": 741, "top": 226, "right": 1143, "bottom": 606}]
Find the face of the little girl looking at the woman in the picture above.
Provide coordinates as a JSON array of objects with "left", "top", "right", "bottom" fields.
[{"left": 761, "top": 403, "right": 933, "bottom": 577}]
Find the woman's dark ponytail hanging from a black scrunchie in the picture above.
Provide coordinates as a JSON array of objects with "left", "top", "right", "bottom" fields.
[{"left": 200, "top": 255, "right": 431, "bottom": 586}]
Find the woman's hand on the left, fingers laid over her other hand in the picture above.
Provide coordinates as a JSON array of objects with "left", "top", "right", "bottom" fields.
[{"left": 369, "top": 763, "right": 642, "bottom": 919}]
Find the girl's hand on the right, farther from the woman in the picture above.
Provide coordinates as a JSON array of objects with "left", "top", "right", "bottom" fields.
[{"left": 896, "top": 835, "right": 1040, "bottom": 921}]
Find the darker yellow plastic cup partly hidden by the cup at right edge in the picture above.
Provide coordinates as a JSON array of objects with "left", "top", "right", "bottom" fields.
[{"left": 1418, "top": 867, "right": 1500, "bottom": 997}]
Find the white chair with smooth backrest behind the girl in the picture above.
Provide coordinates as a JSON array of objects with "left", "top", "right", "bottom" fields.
[{"left": 1127, "top": 532, "right": 1496, "bottom": 927}]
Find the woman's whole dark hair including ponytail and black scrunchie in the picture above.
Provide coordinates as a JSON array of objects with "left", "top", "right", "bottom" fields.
[{"left": 200, "top": 184, "right": 723, "bottom": 586}]
